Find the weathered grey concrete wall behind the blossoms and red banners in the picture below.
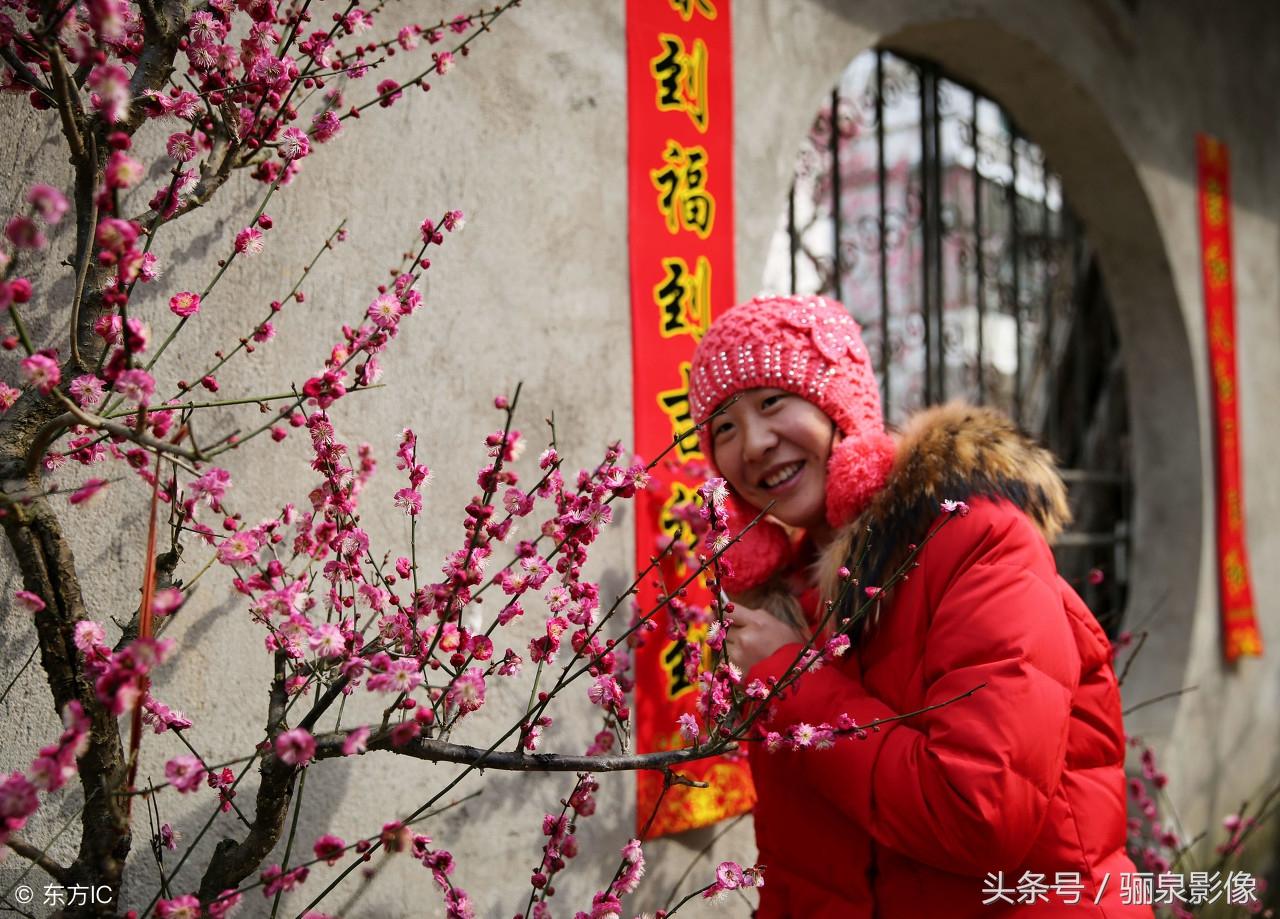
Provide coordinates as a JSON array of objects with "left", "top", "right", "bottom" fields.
[{"left": 0, "top": 0, "right": 1280, "bottom": 916}]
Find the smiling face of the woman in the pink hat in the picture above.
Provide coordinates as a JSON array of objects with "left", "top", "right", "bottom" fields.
[{"left": 712, "top": 388, "right": 836, "bottom": 530}]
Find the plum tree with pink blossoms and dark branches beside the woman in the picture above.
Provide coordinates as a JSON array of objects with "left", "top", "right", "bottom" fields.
[{"left": 0, "top": 0, "right": 962, "bottom": 918}]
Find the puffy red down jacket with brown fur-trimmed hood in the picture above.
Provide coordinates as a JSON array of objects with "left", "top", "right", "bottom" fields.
[{"left": 749, "top": 410, "right": 1152, "bottom": 919}]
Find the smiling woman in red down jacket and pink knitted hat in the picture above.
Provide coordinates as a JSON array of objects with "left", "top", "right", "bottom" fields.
[{"left": 690, "top": 297, "right": 1152, "bottom": 919}]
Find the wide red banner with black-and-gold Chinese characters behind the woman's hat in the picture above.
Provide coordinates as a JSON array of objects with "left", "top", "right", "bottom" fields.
[{"left": 627, "top": 0, "right": 755, "bottom": 836}]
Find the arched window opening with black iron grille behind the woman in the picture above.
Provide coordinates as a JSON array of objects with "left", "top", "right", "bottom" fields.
[{"left": 763, "top": 50, "right": 1132, "bottom": 634}]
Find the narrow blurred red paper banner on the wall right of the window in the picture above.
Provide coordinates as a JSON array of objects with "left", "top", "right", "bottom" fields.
[{"left": 1196, "top": 134, "right": 1262, "bottom": 662}]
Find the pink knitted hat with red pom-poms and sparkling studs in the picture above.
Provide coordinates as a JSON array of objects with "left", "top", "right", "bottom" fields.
[{"left": 689, "top": 294, "right": 893, "bottom": 589}]
